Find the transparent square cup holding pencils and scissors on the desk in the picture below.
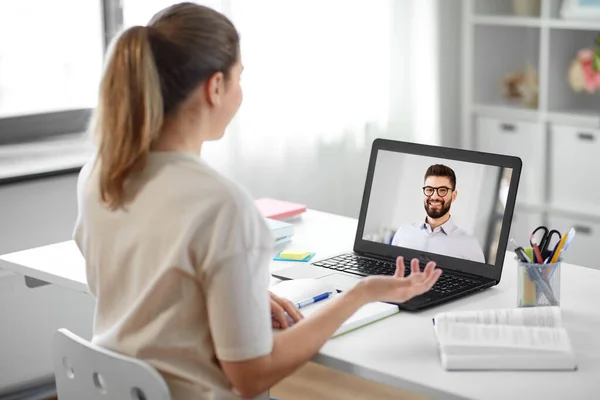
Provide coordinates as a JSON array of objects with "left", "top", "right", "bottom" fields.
[{"left": 517, "top": 259, "right": 562, "bottom": 307}]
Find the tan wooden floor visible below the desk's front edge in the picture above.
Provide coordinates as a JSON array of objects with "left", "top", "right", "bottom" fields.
[{"left": 48, "top": 363, "right": 427, "bottom": 400}]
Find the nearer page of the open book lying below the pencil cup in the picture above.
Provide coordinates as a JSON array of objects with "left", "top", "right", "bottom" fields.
[{"left": 435, "top": 322, "right": 571, "bottom": 352}]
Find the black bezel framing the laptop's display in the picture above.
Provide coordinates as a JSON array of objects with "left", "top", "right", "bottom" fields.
[{"left": 354, "top": 139, "right": 522, "bottom": 282}]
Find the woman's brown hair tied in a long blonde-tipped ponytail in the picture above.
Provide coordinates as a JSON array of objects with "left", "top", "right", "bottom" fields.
[{"left": 91, "top": 3, "right": 239, "bottom": 209}]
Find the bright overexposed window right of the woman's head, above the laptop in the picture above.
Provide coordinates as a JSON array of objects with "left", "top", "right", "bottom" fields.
[{"left": 227, "top": 0, "right": 392, "bottom": 151}]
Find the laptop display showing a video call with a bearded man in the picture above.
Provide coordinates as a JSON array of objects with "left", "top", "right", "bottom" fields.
[{"left": 362, "top": 149, "right": 512, "bottom": 265}]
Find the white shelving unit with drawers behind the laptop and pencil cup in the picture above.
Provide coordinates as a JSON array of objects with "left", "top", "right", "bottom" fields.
[{"left": 462, "top": 0, "right": 600, "bottom": 269}]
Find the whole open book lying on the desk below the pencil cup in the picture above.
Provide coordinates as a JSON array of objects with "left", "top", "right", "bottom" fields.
[{"left": 433, "top": 307, "right": 577, "bottom": 370}]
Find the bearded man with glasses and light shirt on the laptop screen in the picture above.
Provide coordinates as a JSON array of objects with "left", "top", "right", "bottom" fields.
[{"left": 392, "top": 164, "right": 485, "bottom": 263}]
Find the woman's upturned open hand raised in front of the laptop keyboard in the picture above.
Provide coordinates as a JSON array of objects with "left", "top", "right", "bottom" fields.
[{"left": 357, "top": 257, "right": 442, "bottom": 303}]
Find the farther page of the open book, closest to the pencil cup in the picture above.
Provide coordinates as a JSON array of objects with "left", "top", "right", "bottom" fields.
[{"left": 435, "top": 307, "right": 561, "bottom": 327}]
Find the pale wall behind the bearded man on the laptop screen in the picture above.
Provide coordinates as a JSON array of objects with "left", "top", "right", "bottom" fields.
[{"left": 365, "top": 151, "right": 501, "bottom": 250}]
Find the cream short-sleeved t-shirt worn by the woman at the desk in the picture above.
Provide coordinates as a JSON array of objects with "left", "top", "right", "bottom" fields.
[{"left": 74, "top": 152, "right": 273, "bottom": 399}]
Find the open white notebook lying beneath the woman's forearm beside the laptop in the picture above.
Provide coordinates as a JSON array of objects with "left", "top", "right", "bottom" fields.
[{"left": 269, "top": 279, "right": 400, "bottom": 337}]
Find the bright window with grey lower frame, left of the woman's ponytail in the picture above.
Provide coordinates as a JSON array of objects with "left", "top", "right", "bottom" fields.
[{"left": 0, "top": 0, "right": 104, "bottom": 141}]
